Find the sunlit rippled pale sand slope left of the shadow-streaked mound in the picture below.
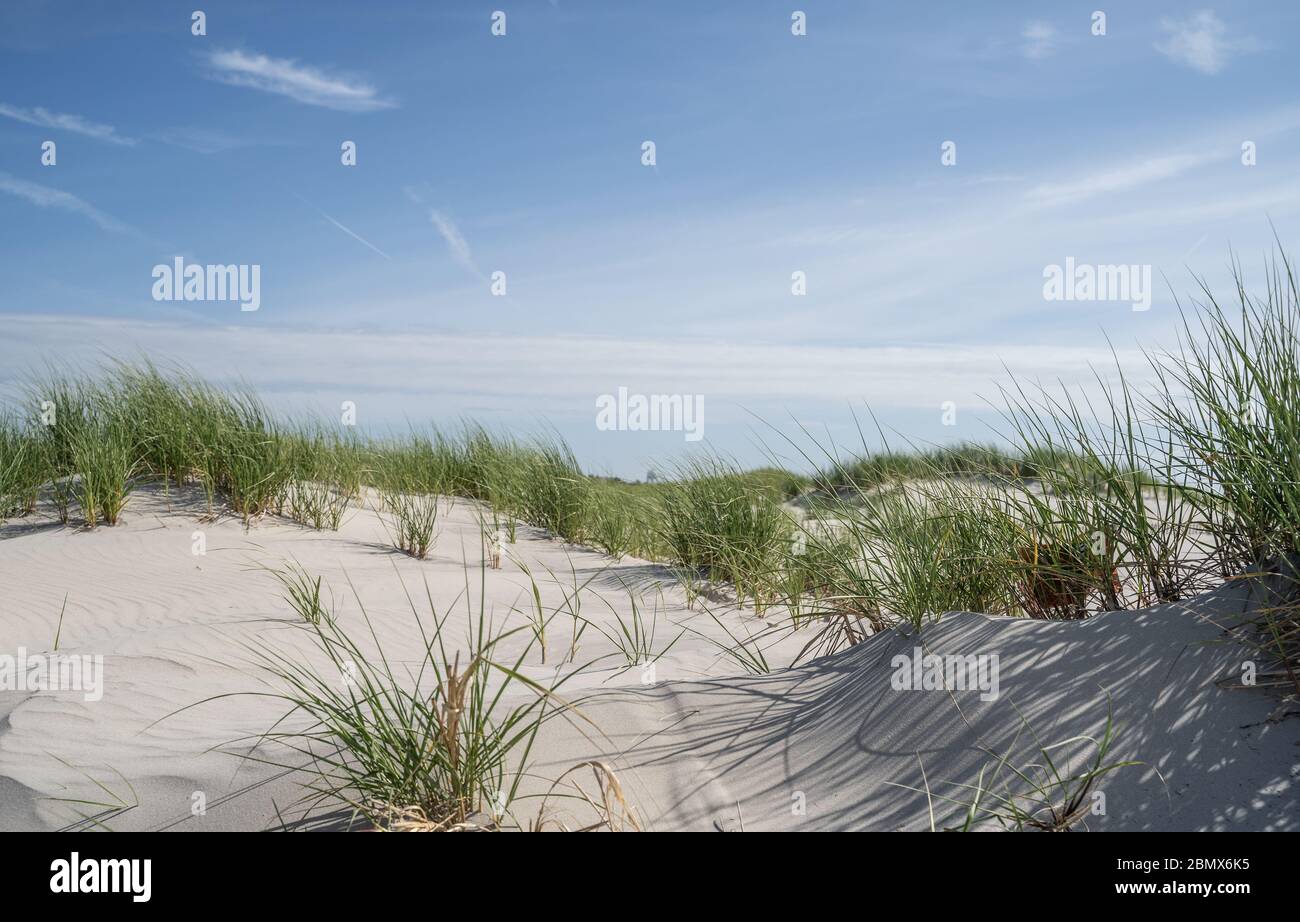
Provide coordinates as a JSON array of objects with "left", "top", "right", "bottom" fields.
[{"left": 0, "top": 492, "right": 802, "bottom": 830}]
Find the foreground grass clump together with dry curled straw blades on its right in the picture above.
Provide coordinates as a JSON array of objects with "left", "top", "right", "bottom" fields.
[{"left": 241, "top": 562, "right": 650, "bottom": 832}]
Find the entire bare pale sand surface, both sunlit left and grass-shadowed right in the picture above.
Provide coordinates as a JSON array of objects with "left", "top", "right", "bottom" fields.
[{"left": 0, "top": 493, "right": 1300, "bottom": 830}]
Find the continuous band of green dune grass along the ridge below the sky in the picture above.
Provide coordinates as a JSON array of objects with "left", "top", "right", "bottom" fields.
[{"left": 0, "top": 248, "right": 1300, "bottom": 691}]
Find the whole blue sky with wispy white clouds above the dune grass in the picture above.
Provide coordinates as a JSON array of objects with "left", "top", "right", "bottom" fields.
[{"left": 0, "top": 0, "right": 1300, "bottom": 476}]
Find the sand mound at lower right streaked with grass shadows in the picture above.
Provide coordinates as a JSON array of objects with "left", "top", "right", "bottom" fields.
[{"left": 538, "top": 589, "right": 1300, "bottom": 830}]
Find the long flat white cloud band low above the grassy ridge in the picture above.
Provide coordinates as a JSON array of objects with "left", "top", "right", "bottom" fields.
[{"left": 0, "top": 312, "right": 1149, "bottom": 419}]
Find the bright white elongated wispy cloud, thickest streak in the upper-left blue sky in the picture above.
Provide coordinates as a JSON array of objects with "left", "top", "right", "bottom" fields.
[{"left": 207, "top": 51, "right": 397, "bottom": 112}]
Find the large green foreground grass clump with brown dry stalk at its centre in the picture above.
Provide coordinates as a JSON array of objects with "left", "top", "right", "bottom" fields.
[{"left": 253, "top": 566, "right": 556, "bottom": 830}]
